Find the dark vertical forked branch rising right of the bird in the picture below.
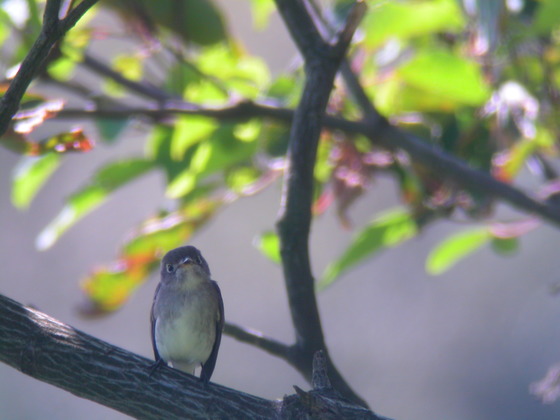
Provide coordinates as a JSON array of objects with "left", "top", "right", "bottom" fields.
[{"left": 276, "top": 0, "right": 367, "bottom": 406}]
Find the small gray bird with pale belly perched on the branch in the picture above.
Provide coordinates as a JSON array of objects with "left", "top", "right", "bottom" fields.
[{"left": 150, "top": 246, "right": 224, "bottom": 383}]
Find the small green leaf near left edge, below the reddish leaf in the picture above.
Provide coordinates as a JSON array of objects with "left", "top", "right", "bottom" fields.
[{"left": 12, "top": 152, "right": 61, "bottom": 209}]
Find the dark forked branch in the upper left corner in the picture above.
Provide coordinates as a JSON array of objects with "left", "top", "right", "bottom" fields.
[{"left": 0, "top": 0, "right": 97, "bottom": 136}]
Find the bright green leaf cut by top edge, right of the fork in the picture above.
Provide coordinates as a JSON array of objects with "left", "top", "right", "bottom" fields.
[{"left": 362, "top": 0, "right": 464, "bottom": 47}]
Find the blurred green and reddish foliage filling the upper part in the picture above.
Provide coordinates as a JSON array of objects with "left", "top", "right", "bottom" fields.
[{"left": 0, "top": 0, "right": 560, "bottom": 313}]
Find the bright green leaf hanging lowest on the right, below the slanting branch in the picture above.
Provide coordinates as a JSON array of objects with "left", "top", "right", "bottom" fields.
[{"left": 426, "top": 227, "right": 492, "bottom": 275}]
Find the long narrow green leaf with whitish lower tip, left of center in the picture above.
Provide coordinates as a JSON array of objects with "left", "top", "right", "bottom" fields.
[{"left": 36, "top": 159, "right": 154, "bottom": 250}]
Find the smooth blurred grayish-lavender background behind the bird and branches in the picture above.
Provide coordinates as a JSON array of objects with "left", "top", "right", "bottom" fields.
[{"left": 0, "top": 0, "right": 560, "bottom": 420}]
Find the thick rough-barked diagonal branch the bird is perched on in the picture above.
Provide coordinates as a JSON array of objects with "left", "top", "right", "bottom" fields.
[{"left": 0, "top": 295, "right": 384, "bottom": 420}]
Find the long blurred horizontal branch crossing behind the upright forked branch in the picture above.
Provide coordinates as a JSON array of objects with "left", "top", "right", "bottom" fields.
[{"left": 51, "top": 97, "right": 560, "bottom": 230}]
